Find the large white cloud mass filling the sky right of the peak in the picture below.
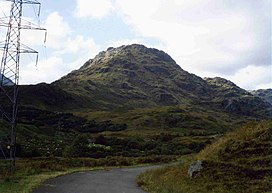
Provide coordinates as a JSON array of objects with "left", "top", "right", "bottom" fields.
[{"left": 116, "top": 0, "right": 271, "bottom": 89}]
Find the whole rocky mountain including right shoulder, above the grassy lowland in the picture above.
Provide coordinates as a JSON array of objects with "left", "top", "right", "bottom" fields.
[{"left": 16, "top": 44, "right": 272, "bottom": 118}]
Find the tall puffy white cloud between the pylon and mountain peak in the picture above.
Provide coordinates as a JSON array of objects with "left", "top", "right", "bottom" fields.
[{"left": 20, "top": 12, "right": 99, "bottom": 84}]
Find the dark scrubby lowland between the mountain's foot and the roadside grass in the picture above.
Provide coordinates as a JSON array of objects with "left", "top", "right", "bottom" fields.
[{"left": 0, "top": 107, "right": 219, "bottom": 158}]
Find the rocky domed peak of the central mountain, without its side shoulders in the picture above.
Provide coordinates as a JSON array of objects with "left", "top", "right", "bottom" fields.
[{"left": 53, "top": 44, "right": 212, "bottom": 110}]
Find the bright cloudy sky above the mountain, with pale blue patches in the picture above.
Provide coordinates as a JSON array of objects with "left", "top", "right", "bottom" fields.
[{"left": 0, "top": 0, "right": 272, "bottom": 90}]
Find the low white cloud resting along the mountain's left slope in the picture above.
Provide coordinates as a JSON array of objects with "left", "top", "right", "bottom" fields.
[{"left": 20, "top": 36, "right": 99, "bottom": 84}]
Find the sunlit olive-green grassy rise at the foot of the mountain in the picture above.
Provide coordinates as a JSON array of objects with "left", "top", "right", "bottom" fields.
[{"left": 75, "top": 105, "right": 248, "bottom": 136}]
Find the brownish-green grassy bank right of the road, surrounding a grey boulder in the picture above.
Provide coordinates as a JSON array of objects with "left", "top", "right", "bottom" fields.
[{"left": 138, "top": 122, "right": 272, "bottom": 193}]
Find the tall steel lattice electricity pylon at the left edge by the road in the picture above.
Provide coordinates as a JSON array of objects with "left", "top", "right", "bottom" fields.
[{"left": 0, "top": 0, "right": 45, "bottom": 170}]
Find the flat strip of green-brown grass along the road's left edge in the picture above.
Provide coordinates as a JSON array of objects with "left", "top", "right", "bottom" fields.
[{"left": 0, "top": 156, "right": 176, "bottom": 193}]
